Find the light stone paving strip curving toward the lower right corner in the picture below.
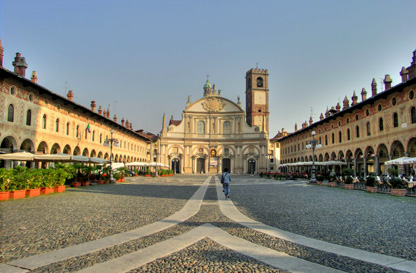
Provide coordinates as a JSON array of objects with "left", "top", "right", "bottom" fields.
[{"left": 215, "top": 177, "right": 416, "bottom": 273}]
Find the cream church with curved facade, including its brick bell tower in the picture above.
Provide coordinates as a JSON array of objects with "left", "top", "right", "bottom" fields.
[{"left": 158, "top": 68, "right": 269, "bottom": 174}]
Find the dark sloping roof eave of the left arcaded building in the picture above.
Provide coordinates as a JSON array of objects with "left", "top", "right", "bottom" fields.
[{"left": 0, "top": 67, "right": 150, "bottom": 141}]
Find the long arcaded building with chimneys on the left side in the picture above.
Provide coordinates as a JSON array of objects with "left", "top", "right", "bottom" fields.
[{"left": 0, "top": 37, "right": 151, "bottom": 167}]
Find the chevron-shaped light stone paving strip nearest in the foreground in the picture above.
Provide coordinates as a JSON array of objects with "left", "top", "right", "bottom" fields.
[{"left": 78, "top": 224, "right": 343, "bottom": 273}]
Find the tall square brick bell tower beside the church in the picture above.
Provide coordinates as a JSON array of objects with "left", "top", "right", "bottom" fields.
[{"left": 246, "top": 68, "right": 269, "bottom": 133}]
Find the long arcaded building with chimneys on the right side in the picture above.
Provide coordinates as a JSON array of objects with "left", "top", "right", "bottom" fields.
[{"left": 278, "top": 51, "right": 416, "bottom": 175}]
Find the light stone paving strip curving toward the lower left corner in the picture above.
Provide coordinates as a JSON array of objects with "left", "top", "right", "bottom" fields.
[{"left": 7, "top": 176, "right": 211, "bottom": 273}]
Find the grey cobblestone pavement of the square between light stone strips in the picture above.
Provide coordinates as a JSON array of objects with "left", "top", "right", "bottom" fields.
[{"left": 0, "top": 175, "right": 416, "bottom": 272}]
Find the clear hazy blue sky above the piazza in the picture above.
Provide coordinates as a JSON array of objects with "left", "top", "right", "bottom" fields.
[{"left": 0, "top": 0, "right": 416, "bottom": 138}]
